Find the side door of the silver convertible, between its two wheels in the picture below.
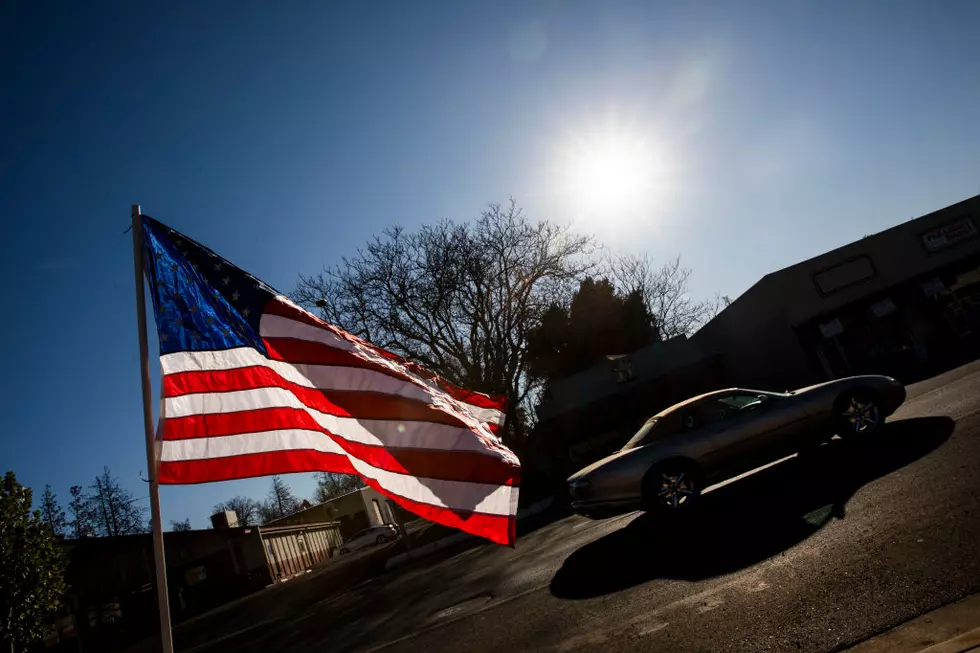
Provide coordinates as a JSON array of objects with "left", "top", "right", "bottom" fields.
[{"left": 682, "top": 391, "right": 779, "bottom": 478}]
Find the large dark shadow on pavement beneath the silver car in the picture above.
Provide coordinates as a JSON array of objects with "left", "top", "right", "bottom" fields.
[{"left": 551, "top": 417, "right": 955, "bottom": 599}]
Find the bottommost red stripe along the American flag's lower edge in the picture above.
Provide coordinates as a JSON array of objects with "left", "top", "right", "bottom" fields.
[{"left": 159, "top": 451, "right": 516, "bottom": 544}]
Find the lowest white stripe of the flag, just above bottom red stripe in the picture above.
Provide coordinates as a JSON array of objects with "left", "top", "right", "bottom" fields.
[{"left": 161, "top": 430, "right": 513, "bottom": 515}]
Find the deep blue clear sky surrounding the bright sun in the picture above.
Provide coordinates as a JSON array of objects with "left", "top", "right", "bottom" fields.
[{"left": 0, "top": 0, "right": 980, "bottom": 527}]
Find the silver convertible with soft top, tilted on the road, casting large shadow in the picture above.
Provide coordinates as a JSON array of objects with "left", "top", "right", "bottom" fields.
[{"left": 568, "top": 376, "right": 905, "bottom": 518}]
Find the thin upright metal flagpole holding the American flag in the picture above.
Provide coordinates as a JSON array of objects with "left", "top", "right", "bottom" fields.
[{"left": 132, "top": 204, "right": 174, "bottom": 653}]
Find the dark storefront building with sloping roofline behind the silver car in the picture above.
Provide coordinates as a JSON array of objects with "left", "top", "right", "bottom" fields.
[{"left": 695, "top": 196, "right": 980, "bottom": 389}]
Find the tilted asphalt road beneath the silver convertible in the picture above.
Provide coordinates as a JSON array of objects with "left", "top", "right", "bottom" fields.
[{"left": 191, "top": 364, "right": 980, "bottom": 653}]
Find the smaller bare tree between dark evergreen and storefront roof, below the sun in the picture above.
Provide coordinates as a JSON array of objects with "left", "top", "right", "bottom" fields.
[{"left": 606, "top": 254, "right": 723, "bottom": 340}]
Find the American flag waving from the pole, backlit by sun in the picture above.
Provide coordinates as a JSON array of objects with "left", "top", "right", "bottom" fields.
[{"left": 141, "top": 216, "right": 520, "bottom": 545}]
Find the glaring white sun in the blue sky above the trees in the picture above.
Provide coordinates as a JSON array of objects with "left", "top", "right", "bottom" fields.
[{"left": 562, "top": 130, "right": 667, "bottom": 217}]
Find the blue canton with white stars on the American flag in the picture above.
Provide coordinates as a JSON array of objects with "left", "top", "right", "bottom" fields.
[{"left": 141, "top": 215, "right": 279, "bottom": 355}]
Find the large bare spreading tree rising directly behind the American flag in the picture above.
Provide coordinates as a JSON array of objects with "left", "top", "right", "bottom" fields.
[{"left": 294, "top": 200, "right": 594, "bottom": 448}]
